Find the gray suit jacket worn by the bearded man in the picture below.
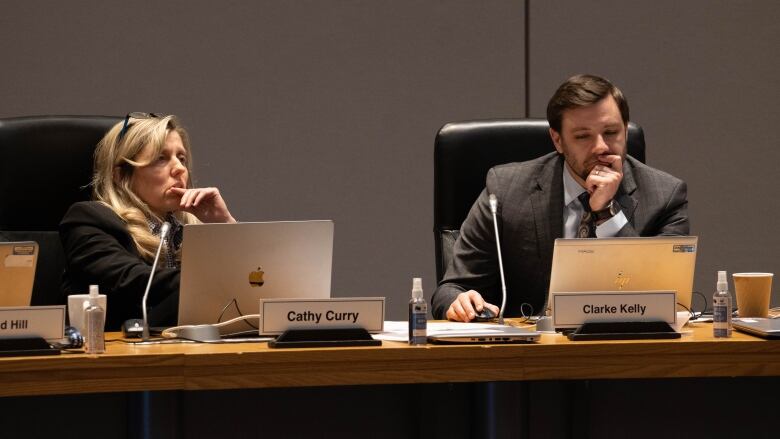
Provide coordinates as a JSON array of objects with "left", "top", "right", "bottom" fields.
[{"left": 431, "top": 152, "right": 689, "bottom": 319}]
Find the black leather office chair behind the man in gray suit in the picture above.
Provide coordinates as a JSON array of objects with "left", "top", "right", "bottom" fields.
[{"left": 433, "top": 119, "right": 645, "bottom": 282}]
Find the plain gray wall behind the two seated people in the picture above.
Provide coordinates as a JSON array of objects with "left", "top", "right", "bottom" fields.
[{"left": 0, "top": 0, "right": 780, "bottom": 319}]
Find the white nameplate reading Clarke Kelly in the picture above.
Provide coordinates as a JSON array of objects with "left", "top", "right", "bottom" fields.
[{"left": 551, "top": 291, "right": 677, "bottom": 329}]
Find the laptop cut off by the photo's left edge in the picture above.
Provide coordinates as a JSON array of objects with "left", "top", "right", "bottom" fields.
[{"left": 0, "top": 241, "right": 38, "bottom": 306}]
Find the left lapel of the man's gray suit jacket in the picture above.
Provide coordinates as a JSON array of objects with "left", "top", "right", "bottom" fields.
[{"left": 531, "top": 155, "right": 563, "bottom": 260}]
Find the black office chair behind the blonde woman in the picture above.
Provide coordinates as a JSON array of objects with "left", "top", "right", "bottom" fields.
[{"left": 0, "top": 116, "right": 122, "bottom": 305}]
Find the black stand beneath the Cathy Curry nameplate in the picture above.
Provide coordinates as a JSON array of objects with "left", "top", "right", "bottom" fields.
[{"left": 268, "top": 328, "right": 382, "bottom": 348}]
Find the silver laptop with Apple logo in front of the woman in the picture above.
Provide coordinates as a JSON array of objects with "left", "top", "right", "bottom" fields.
[{"left": 179, "top": 221, "right": 333, "bottom": 334}]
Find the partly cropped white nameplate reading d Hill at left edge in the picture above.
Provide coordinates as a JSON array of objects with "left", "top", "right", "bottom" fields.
[{"left": 0, "top": 305, "right": 65, "bottom": 340}]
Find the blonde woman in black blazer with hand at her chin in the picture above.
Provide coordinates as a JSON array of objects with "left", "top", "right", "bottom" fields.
[{"left": 60, "top": 113, "right": 236, "bottom": 330}]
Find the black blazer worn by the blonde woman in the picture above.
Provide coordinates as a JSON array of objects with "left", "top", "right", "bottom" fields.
[{"left": 60, "top": 201, "right": 180, "bottom": 331}]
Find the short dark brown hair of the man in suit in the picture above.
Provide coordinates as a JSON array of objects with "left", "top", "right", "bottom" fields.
[{"left": 547, "top": 75, "right": 628, "bottom": 133}]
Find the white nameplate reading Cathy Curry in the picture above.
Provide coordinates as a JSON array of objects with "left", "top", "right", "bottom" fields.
[{"left": 260, "top": 297, "right": 385, "bottom": 335}]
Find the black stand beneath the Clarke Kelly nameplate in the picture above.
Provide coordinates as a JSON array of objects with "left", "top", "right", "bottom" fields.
[{"left": 567, "top": 322, "right": 681, "bottom": 341}]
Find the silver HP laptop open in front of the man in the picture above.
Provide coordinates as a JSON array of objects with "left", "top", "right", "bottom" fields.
[{"left": 548, "top": 236, "right": 698, "bottom": 311}]
